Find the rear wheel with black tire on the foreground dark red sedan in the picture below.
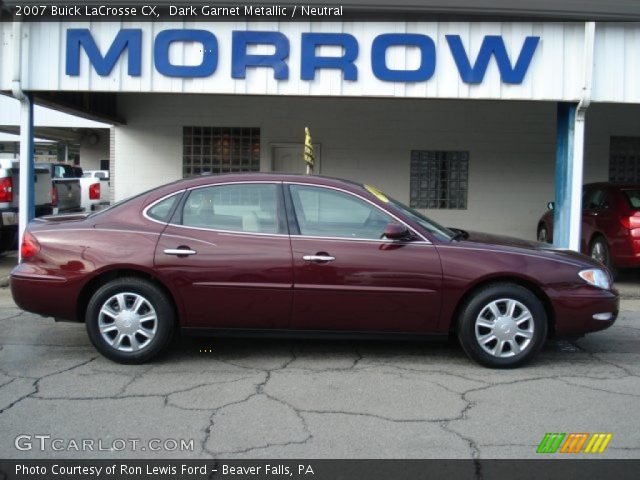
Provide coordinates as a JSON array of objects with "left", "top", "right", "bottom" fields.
[{"left": 85, "top": 277, "right": 175, "bottom": 364}]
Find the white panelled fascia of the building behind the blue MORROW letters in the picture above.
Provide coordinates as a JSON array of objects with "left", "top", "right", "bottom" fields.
[{"left": 0, "top": 19, "right": 640, "bottom": 103}]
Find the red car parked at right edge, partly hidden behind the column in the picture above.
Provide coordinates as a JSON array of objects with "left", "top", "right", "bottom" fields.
[{"left": 538, "top": 183, "right": 640, "bottom": 275}]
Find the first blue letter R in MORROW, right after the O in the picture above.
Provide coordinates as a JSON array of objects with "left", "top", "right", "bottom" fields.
[{"left": 231, "top": 31, "right": 289, "bottom": 80}]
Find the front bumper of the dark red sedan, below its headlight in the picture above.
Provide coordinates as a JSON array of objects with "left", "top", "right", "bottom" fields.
[{"left": 547, "top": 285, "right": 620, "bottom": 335}]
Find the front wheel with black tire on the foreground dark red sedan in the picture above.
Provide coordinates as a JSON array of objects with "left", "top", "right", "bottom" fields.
[{"left": 457, "top": 283, "right": 548, "bottom": 368}]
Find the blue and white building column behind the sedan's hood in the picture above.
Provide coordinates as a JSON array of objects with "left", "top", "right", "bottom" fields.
[{"left": 553, "top": 103, "right": 585, "bottom": 252}]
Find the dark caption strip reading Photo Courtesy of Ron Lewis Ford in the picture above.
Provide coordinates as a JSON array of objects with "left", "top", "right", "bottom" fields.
[{"left": 0, "top": 459, "right": 640, "bottom": 480}]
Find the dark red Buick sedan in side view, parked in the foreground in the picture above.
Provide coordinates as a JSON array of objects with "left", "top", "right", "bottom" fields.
[{"left": 11, "top": 174, "right": 618, "bottom": 367}]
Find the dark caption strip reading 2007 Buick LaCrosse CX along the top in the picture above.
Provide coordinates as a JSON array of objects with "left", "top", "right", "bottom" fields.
[{"left": 0, "top": 0, "right": 640, "bottom": 22}]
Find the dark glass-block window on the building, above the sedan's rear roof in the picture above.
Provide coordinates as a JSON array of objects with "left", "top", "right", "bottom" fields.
[{"left": 182, "top": 127, "right": 260, "bottom": 178}]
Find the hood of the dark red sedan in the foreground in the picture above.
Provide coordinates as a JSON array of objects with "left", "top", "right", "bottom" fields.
[{"left": 460, "top": 231, "right": 602, "bottom": 268}]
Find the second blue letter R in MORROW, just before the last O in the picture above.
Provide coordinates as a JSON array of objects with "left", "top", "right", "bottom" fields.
[{"left": 300, "top": 33, "right": 358, "bottom": 81}]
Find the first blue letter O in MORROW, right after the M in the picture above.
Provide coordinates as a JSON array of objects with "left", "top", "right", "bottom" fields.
[{"left": 153, "top": 30, "right": 218, "bottom": 78}]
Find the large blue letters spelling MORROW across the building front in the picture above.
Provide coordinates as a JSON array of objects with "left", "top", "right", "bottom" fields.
[{"left": 65, "top": 28, "right": 540, "bottom": 84}]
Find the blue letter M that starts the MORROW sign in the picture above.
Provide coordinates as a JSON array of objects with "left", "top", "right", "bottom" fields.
[{"left": 65, "top": 28, "right": 142, "bottom": 77}]
